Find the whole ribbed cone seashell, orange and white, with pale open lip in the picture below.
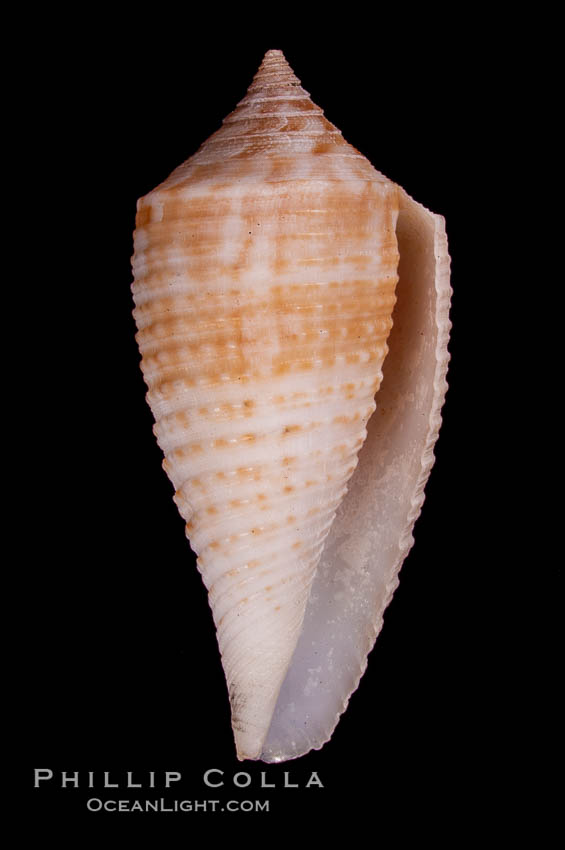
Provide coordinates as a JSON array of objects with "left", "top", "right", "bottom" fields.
[{"left": 132, "top": 50, "right": 451, "bottom": 762}]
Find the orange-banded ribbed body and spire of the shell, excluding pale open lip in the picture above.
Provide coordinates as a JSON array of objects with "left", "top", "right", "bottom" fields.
[{"left": 133, "top": 50, "right": 450, "bottom": 761}]
